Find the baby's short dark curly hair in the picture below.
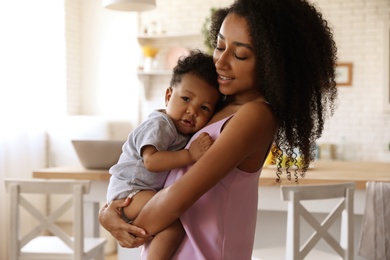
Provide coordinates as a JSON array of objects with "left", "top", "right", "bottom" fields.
[{"left": 170, "top": 50, "right": 219, "bottom": 92}]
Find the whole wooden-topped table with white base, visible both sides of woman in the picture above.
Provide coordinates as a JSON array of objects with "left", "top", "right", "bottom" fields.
[{"left": 33, "top": 161, "right": 390, "bottom": 259}]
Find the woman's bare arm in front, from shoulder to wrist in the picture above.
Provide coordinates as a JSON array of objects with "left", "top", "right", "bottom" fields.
[{"left": 134, "top": 102, "right": 276, "bottom": 234}]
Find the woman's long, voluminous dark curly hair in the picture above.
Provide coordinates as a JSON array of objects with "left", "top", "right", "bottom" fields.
[{"left": 209, "top": 0, "right": 337, "bottom": 181}]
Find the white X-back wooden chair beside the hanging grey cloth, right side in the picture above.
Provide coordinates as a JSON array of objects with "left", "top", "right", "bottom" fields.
[{"left": 252, "top": 183, "right": 355, "bottom": 260}]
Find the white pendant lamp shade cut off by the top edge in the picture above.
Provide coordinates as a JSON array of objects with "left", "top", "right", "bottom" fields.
[{"left": 103, "top": 0, "right": 156, "bottom": 12}]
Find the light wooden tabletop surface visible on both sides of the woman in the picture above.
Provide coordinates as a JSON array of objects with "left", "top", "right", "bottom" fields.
[{"left": 33, "top": 161, "right": 390, "bottom": 189}]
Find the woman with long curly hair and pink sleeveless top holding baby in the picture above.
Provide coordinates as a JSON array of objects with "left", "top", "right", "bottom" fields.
[{"left": 99, "top": 0, "right": 336, "bottom": 259}]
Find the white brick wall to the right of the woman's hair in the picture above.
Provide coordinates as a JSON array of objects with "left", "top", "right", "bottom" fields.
[{"left": 316, "top": 0, "right": 390, "bottom": 161}]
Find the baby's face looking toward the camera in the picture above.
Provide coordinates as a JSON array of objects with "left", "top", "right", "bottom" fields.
[{"left": 165, "top": 74, "right": 220, "bottom": 134}]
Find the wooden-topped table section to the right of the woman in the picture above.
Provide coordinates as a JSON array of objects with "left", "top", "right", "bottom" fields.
[{"left": 258, "top": 161, "right": 390, "bottom": 215}]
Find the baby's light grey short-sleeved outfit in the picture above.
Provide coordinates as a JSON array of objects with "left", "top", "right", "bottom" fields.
[{"left": 107, "top": 110, "right": 190, "bottom": 202}]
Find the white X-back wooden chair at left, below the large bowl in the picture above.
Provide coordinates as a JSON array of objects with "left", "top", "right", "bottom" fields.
[{"left": 5, "top": 179, "right": 106, "bottom": 260}]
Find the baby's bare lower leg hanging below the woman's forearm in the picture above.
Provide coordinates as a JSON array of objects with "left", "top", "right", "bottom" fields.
[{"left": 147, "top": 219, "right": 185, "bottom": 260}]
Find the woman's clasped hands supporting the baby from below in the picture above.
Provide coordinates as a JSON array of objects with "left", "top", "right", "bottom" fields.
[{"left": 99, "top": 199, "right": 150, "bottom": 248}]
